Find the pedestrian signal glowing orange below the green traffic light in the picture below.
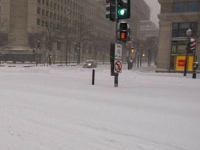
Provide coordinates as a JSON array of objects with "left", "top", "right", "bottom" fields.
[{"left": 117, "top": 22, "right": 130, "bottom": 42}]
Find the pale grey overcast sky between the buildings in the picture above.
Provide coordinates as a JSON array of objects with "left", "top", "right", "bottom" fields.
[{"left": 145, "top": 0, "right": 160, "bottom": 26}]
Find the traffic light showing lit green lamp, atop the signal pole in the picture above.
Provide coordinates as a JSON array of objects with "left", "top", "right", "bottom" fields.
[{"left": 117, "top": 0, "right": 131, "bottom": 19}]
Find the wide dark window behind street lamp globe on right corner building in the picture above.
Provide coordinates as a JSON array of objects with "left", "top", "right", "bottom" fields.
[{"left": 172, "top": 22, "right": 198, "bottom": 37}]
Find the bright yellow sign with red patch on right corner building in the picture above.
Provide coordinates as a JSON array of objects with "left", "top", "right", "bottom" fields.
[{"left": 175, "top": 56, "right": 194, "bottom": 71}]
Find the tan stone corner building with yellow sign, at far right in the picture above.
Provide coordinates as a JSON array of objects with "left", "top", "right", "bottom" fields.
[{"left": 157, "top": 0, "right": 200, "bottom": 71}]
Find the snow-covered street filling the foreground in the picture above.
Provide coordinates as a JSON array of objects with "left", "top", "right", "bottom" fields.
[{"left": 0, "top": 65, "right": 200, "bottom": 150}]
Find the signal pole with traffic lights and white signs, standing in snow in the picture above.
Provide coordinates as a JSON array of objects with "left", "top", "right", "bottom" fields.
[{"left": 106, "top": 0, "right": 131, "bottom": 87}]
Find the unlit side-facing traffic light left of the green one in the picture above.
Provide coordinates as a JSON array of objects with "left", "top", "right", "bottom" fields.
[{"left": 106, "top": 0, "right": 116, "bottom": 21}]
